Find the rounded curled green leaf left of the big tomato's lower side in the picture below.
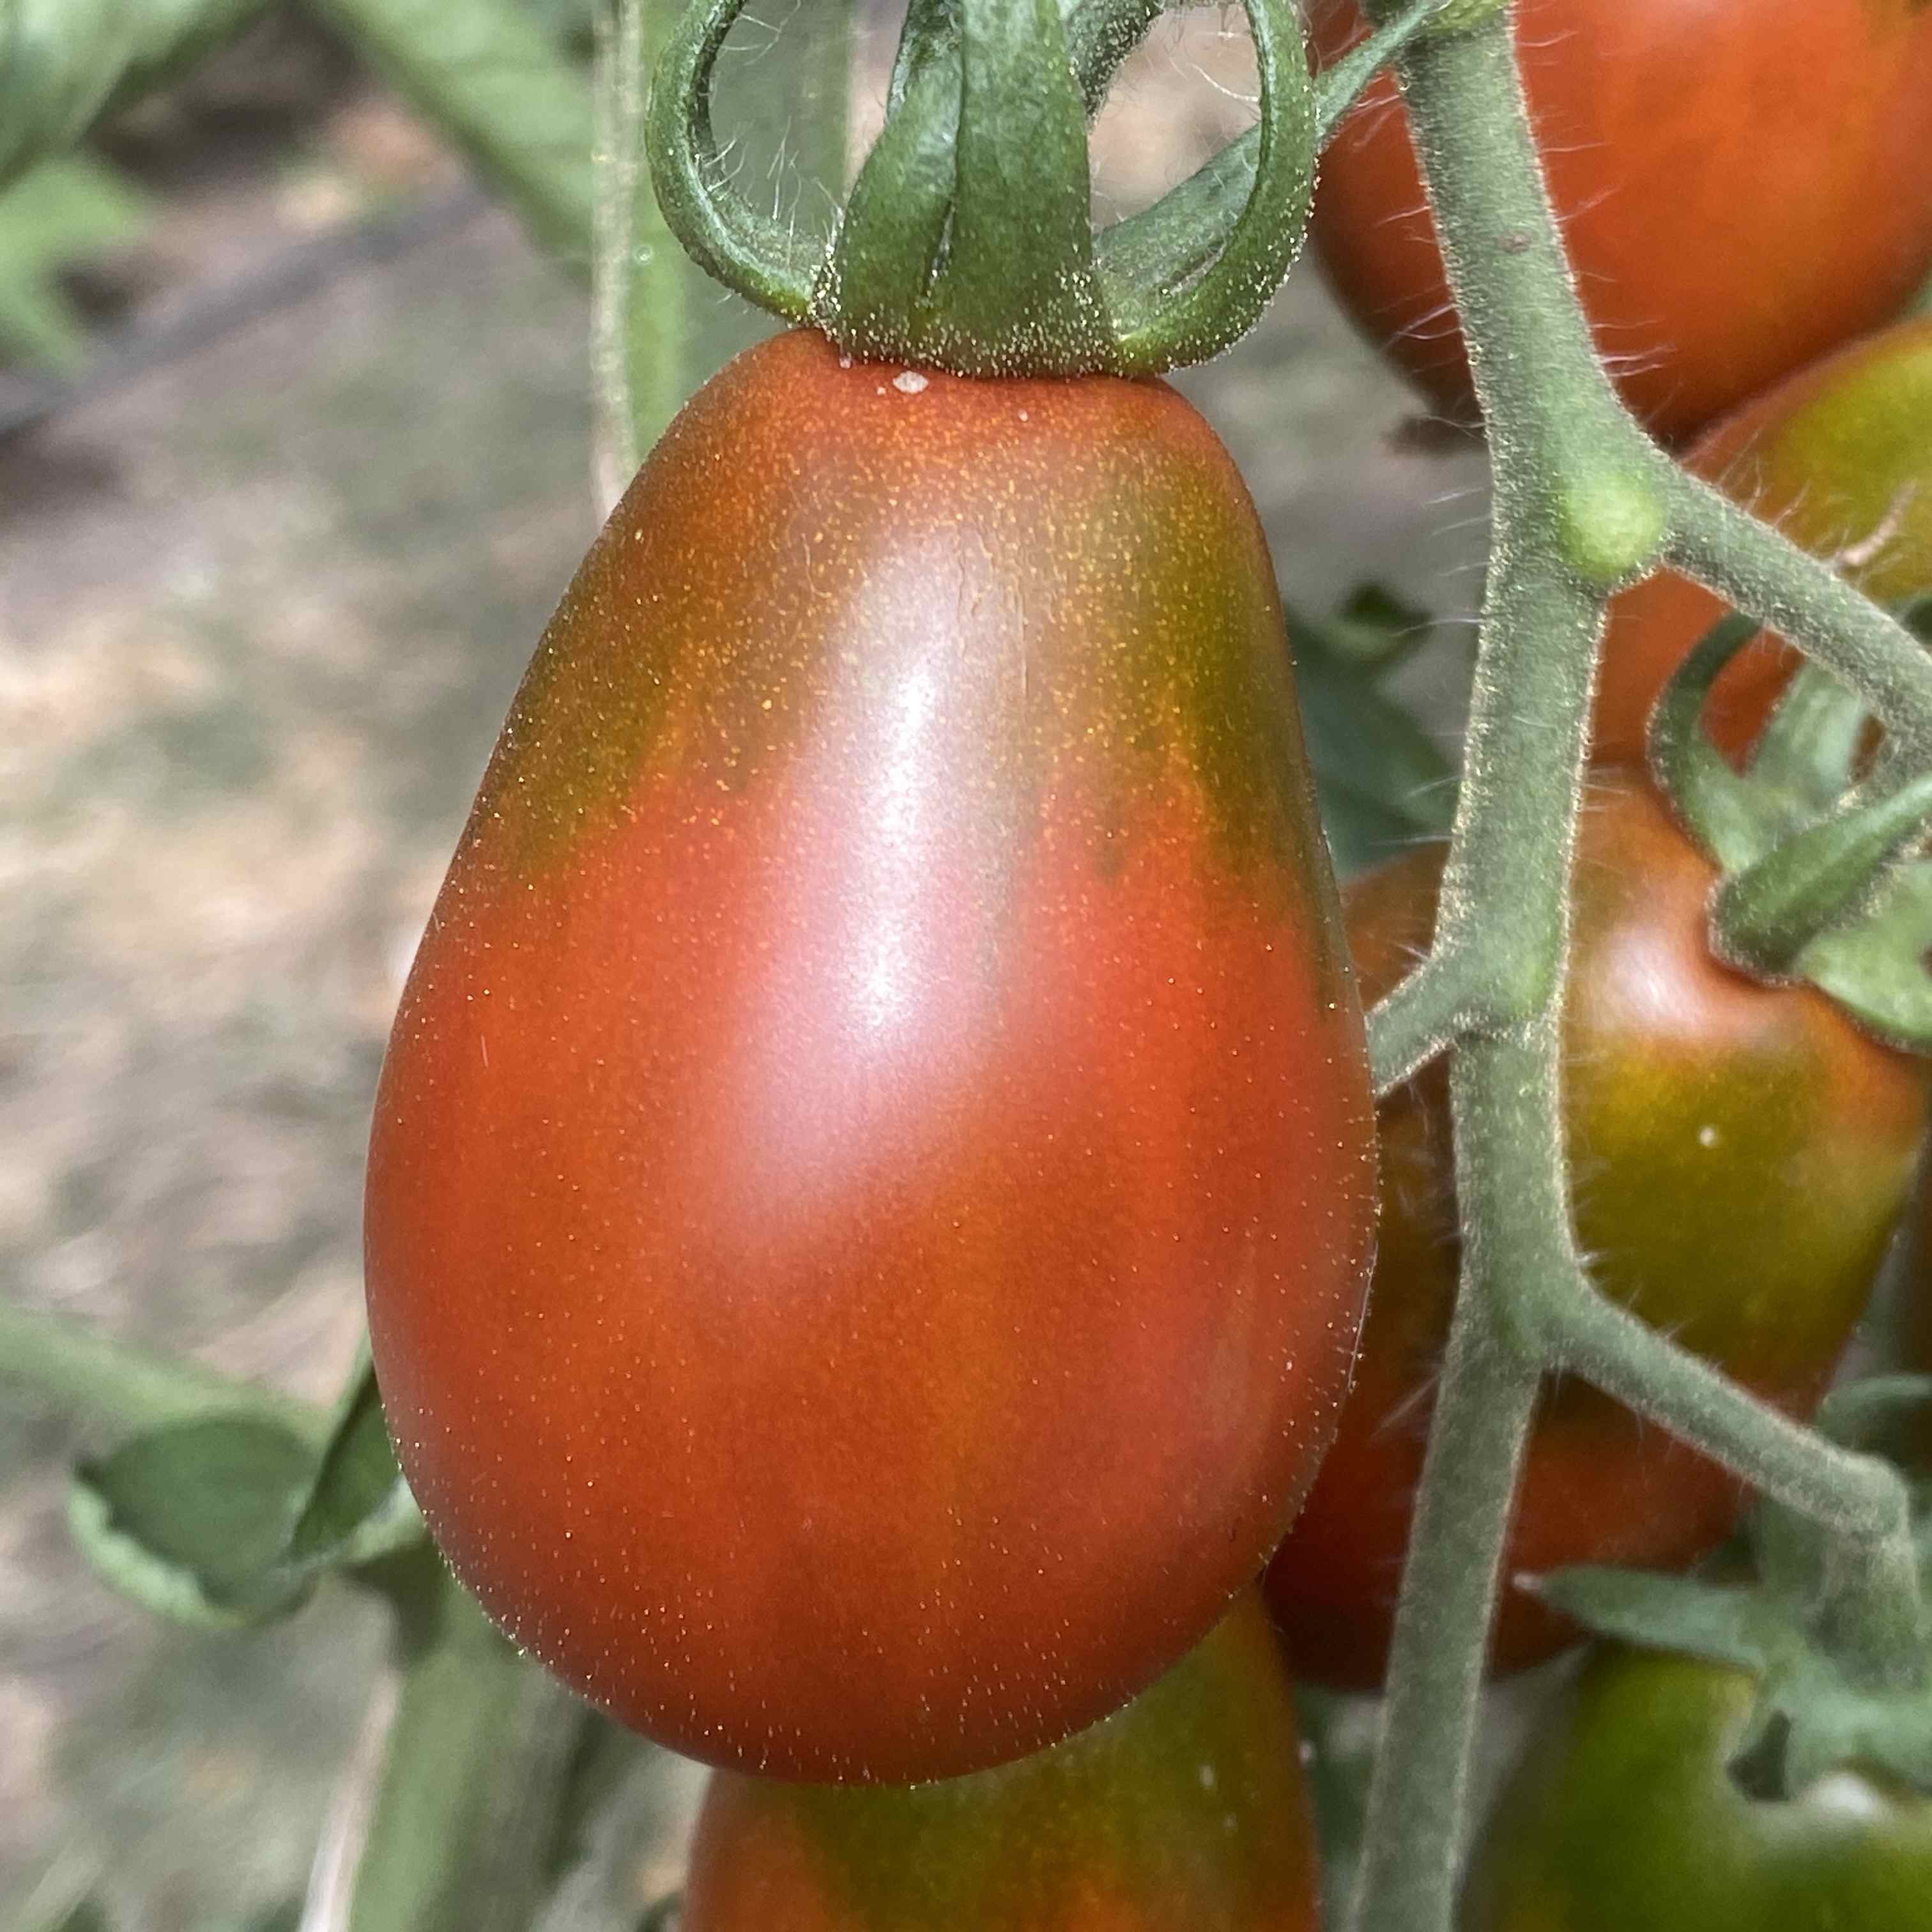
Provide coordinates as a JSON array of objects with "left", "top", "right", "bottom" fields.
[{"left": 68, "top": 1416, "right": 315, "bottom": 1629}]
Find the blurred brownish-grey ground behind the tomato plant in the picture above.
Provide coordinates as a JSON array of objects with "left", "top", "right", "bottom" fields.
[{"left": 0, "top": 0, "right": 1483, "bottom": 1932}]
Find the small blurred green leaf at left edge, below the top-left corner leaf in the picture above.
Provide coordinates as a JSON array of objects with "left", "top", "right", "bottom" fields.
[{"left": 0, "top": 155, "right": 149, "bottom": 375}]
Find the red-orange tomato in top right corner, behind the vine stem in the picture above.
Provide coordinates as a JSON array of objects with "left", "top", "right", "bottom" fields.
[{"left": 1310, "top": 0, "right": 1932, "bottom": 440}]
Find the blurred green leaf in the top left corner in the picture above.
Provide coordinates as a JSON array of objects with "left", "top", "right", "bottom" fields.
[{"left": 0, "top": 0, "right": 266, "bottom": 183}]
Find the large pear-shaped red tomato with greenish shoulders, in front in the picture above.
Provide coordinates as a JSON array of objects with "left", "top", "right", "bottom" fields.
[{"left": 355, "top": 332, "right": 1376, "bottom": 1781}]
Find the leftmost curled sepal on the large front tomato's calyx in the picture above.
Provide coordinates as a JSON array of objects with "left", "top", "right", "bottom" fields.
[{"left": 645, "top": 0, "right": 819, "bottom": 323}]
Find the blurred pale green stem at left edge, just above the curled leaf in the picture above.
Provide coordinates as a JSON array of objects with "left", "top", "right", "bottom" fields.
[{"left": 0, "top": 1300, "right": 328, "bottom": 1443}]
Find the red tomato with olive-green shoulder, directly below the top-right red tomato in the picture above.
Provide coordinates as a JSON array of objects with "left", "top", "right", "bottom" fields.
[{"left": 1594, "top": 314, "right": 1932, "bottom": 763}]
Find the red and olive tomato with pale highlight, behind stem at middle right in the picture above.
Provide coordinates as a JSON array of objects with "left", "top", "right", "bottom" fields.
[{"left": 1268, "top": 771, "right": 1932, "bottom": 1689}]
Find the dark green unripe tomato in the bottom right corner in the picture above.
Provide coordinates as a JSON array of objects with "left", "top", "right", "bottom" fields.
[{"left": 1459, "top": 1648, "right": 1932, "bottom": 1932}]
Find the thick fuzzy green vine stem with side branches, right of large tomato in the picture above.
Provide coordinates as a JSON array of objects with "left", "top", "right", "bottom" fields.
[{"left": 1353, "top": 8, "right": 1932, "bottom": 1932}]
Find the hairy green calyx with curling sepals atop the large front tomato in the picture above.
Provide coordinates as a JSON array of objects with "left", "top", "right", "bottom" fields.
[{"left": 649, "top": 0, "right": 1441, "bottom": 377}]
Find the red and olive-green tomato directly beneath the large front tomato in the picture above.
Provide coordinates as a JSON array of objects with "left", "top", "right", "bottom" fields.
[{"left": 680, "top": 1590, "right": 1317, "bottom": 1932}]
